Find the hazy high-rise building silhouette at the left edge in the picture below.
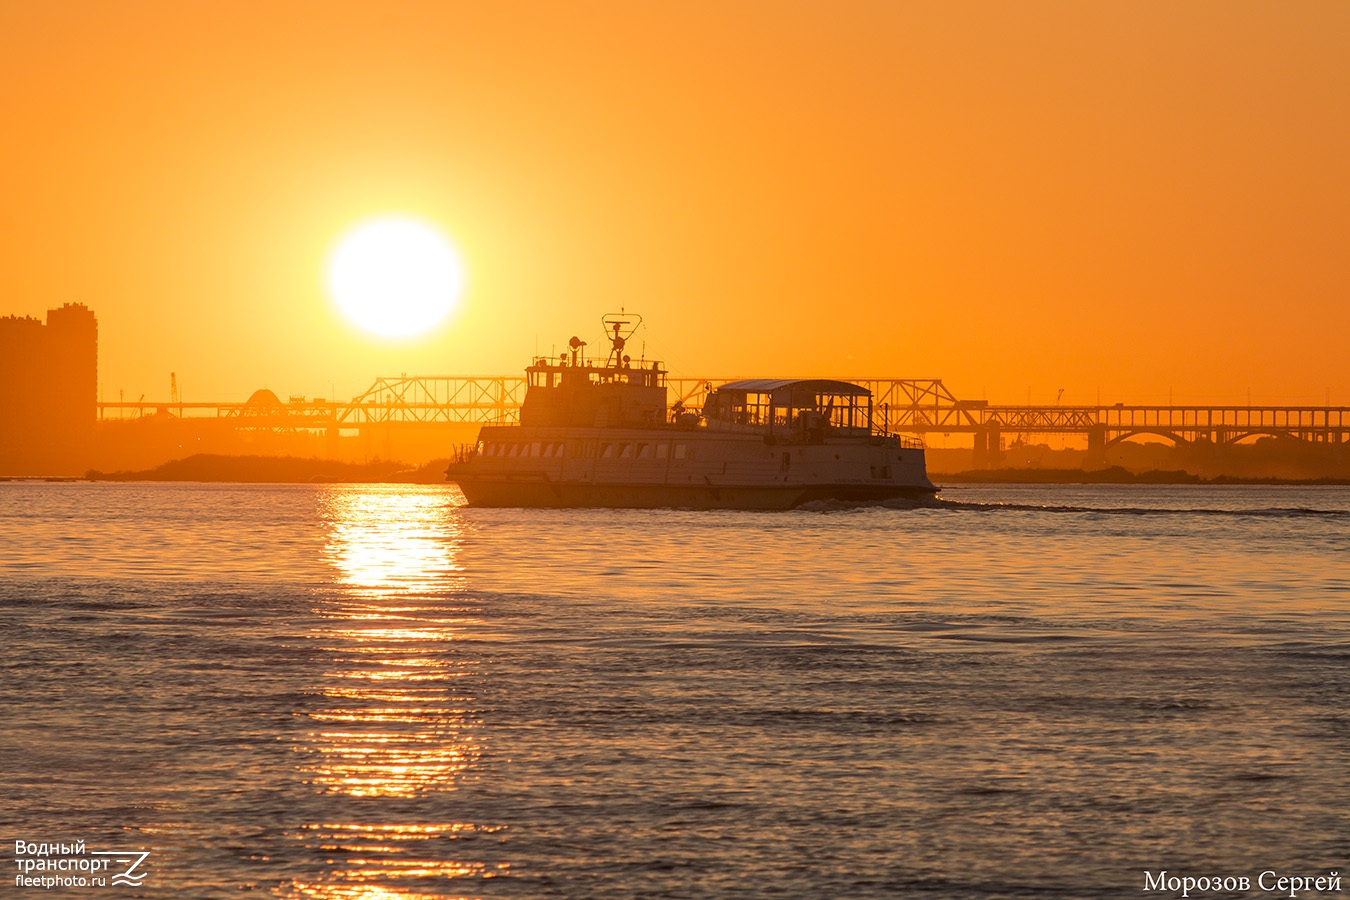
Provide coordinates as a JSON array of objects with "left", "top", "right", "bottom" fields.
[{"left": 0, "top": 304, "right": 99, "bottom": 475}]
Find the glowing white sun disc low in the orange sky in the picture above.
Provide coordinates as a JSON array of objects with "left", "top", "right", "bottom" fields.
[{"left": 328, "top": 216, "right": 464, "bottom": 337}]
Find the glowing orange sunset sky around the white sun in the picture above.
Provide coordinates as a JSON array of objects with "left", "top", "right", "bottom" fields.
[{"left": 0, "top": 0, "right": 1350, "bottom": 405}]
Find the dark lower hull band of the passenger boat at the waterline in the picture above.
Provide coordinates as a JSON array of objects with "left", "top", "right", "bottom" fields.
[{"left": 451, "top": 474, "right": 937, "bottom": 510}]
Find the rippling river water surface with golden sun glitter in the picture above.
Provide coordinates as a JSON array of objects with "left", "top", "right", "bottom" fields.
[{"left": 0, "top": 483, "right": 1350, "bottom": 900}]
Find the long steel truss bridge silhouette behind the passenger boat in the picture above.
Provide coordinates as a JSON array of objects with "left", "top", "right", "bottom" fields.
[{"left": 99, "top": 375, "right": 1350, "bottom": 457}]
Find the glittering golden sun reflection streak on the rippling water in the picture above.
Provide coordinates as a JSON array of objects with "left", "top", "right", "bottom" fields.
[{"left": 282, "top": 487, "right": 508, "bottom": 900}]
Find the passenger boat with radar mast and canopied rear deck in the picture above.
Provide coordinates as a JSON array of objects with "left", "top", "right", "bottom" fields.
[{"left": 446, "top": 313, "right": 937, "bottom": 510}]
